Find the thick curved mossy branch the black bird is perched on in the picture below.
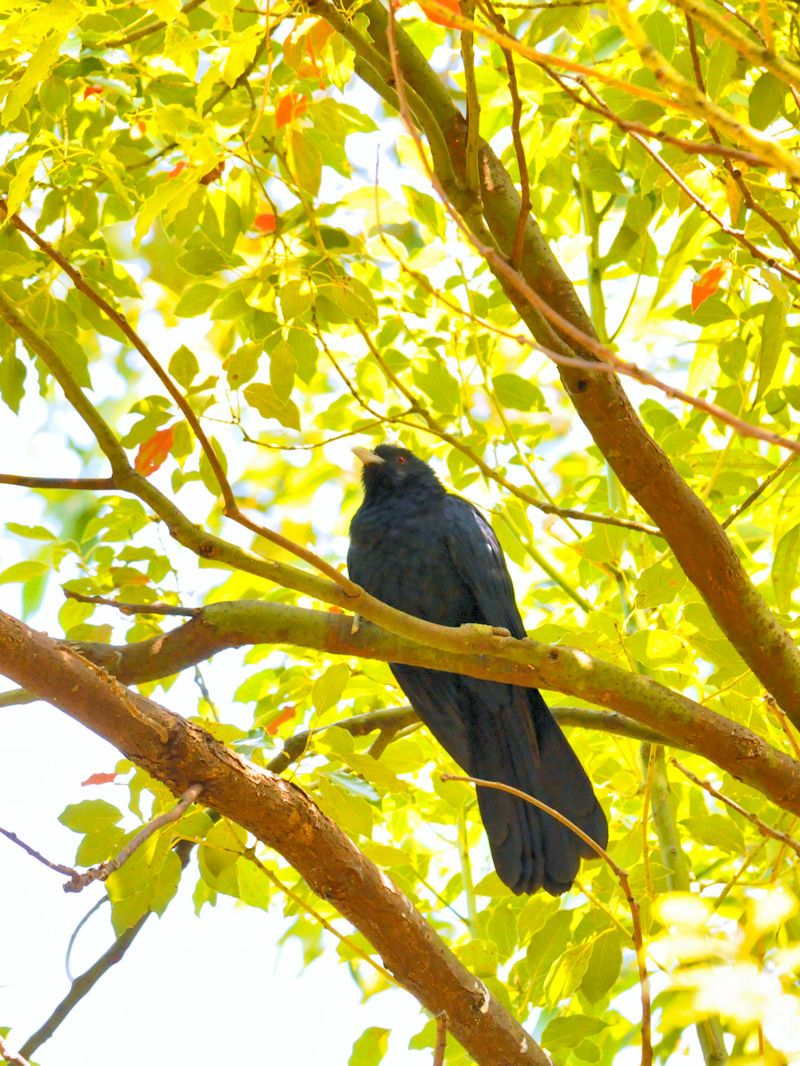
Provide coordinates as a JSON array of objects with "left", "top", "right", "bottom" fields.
[{"left": 64, "top": 600, "right": 800, "bottom": 813}]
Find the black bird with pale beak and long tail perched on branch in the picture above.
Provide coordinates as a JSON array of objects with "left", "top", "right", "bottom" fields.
[{"left": 348, "top": 445, "right": 608, "bottom": 895}]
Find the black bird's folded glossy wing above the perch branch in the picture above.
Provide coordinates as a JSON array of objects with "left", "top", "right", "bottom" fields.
[{"left": 444, "top": 496, "right": 525, "bottom": 637}]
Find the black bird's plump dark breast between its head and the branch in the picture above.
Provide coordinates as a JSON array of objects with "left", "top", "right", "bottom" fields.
[{"left": 348, "top": 496, "right": 480, "bottom": 626}]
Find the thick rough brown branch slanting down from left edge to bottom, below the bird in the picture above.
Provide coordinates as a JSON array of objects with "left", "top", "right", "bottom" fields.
[{"left": 0, "top": 612, "right": 549, "bottom": 1066}]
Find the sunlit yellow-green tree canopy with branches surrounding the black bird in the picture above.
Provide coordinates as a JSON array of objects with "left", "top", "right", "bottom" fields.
[{"left": 0, "top": 0, "right": 800, "bottom": 1066}]
